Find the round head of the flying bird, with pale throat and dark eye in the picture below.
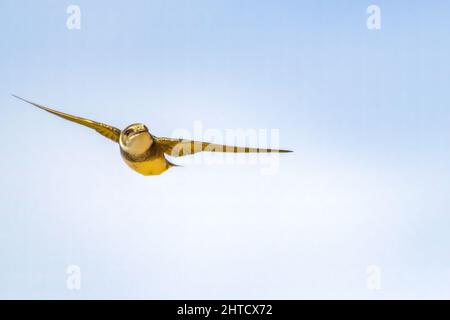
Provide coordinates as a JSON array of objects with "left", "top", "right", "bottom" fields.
[{"left": 119, "top": 123, "right": 153, "bottom": 155}]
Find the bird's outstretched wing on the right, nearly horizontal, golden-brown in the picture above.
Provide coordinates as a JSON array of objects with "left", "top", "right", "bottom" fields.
[{"left": 153, "top": 137, "right": 292, "bottom": 157}]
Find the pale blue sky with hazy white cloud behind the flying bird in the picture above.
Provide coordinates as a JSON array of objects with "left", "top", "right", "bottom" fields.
[{"left": 0, "top": 0, "right": 450, "bottom": 299}]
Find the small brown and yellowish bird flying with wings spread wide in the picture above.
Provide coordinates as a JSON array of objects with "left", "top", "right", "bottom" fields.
[{"left": 12, "top": 94, "right": 292, "bottom": 176}]
